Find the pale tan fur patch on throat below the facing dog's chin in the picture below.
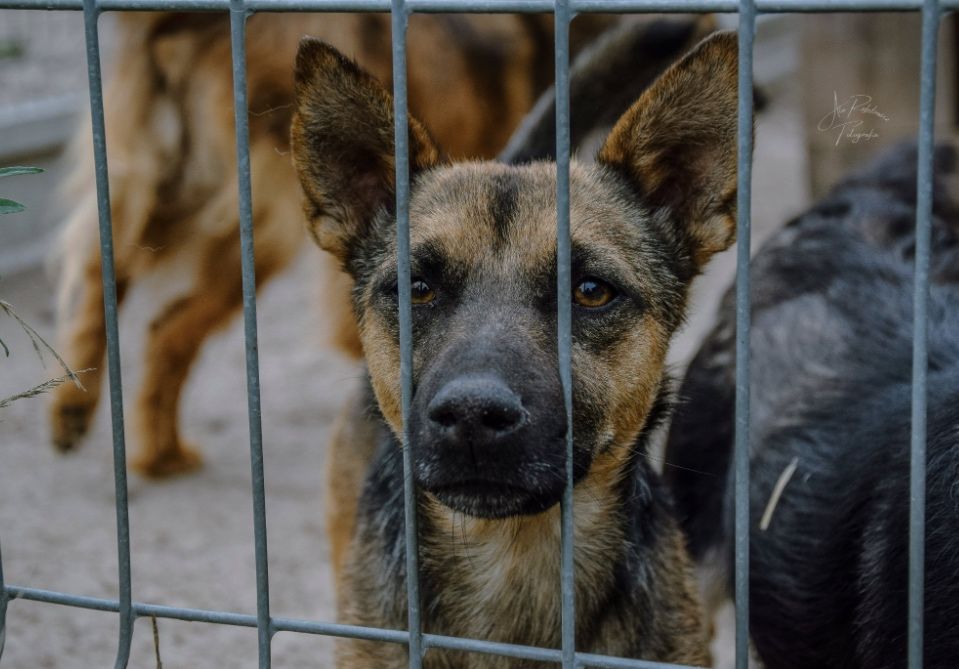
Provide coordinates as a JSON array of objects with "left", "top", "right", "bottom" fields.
[{"left": 423, "top": 470, "right": 627, "bottom": 647}]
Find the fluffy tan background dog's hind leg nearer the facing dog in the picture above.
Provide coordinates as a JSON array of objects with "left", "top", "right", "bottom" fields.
[{"left": 131, "top": 137, "right": 304, "bottom": 478}]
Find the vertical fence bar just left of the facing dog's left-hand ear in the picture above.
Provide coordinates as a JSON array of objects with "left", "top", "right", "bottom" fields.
[{"left": 230, "top": 0, "right": 273, "bottom": 669}]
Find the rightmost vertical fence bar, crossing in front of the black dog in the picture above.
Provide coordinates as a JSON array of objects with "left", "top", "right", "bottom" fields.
[{"left": 908, "top": 0, "right": 940, "bottom": 669}]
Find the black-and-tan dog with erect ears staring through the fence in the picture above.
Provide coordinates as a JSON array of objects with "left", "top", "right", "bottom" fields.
[{"left": 291, "top": 24, "right": 738, "bottom": 669}]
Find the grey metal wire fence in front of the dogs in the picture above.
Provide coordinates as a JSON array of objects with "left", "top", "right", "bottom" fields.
[{"left": 0, "top": 0, "right": 959, "bottom": 669}]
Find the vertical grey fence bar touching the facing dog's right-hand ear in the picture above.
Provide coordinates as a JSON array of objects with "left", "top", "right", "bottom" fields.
[{"left": 735, "top": 0, "right": 756, "bottom": 669}]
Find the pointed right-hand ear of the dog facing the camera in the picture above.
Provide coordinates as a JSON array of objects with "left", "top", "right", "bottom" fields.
[{"left": 597, "top": 32, "right": 739, "bottom": 268}]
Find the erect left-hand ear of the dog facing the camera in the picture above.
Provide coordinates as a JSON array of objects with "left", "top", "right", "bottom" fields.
[{"left": 290, "top": 37, "right": 440, "bottom": 264}]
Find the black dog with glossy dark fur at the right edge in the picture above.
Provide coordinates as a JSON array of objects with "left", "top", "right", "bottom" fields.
[{"left": 666, "top": 144, "right": 959, "bottom": 669}]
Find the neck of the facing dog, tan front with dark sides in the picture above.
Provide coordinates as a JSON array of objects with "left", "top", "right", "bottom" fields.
[{"left": 350, "top": 381, "right": 685, "bottom": 666}]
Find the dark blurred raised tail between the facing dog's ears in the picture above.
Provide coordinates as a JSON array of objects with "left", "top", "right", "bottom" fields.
[{"left": 499, "top": 14, "right": 716, "bottom": 165}]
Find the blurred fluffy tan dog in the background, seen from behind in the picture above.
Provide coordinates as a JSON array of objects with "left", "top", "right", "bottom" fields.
[{"left": 50, "top": 13, "right": 616, "bottom": 477}]
